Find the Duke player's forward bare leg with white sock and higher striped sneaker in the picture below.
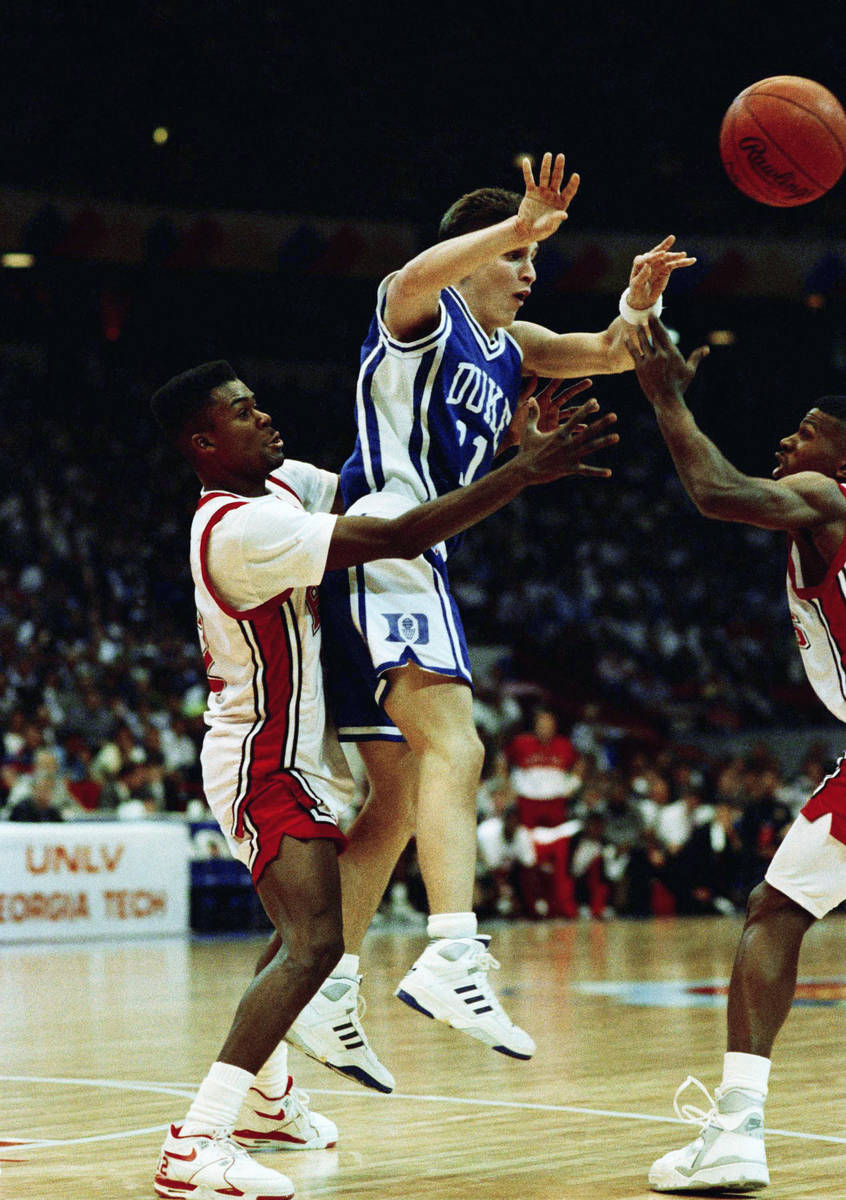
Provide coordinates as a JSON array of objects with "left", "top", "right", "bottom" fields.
[{"left": 384, "top": 665, "right": 535, "bottom": 1058}]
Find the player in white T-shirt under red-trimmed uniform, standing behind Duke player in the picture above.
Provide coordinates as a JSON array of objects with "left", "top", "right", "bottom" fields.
[{"left": 152, "top": 362, "right": 617, "bottom": 1200}]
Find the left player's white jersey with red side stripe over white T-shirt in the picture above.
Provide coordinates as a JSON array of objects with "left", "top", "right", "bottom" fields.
[{"left": 191, "top": 462, "right": 352, "bottom": 836}]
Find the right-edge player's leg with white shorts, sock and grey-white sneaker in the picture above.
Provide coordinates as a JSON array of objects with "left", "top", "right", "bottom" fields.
[{"left": 649, "top": 797, "right": 846, "bottom": 1192}]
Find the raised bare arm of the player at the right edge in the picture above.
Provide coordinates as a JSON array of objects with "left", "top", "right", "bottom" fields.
[{"left": 629, "top": 317, "right": 846, "bottom": 532}]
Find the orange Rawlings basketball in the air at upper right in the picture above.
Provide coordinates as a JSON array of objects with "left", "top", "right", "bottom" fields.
[{"left": 720, "top": 76, "right": 846, "bottom": 208}]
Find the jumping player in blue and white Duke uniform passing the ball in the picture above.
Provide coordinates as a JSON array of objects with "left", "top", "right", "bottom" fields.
[{"left": 309, "top": 154, "right": 694, "bottom": 1058}]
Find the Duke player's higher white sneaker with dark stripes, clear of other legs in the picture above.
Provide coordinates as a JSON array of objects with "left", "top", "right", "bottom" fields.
[{"left": 394, "top": 935, "right": 535, "bottom": 1058}]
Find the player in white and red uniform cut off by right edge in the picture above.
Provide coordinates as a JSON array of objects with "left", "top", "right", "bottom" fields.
[{"left": 630, "top": 320, "right": 846, "bottom": 1192}]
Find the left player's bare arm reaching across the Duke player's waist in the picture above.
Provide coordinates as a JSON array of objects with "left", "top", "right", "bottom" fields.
[{"left": 326, "top": 400, "right": 618, "bottom": 571}]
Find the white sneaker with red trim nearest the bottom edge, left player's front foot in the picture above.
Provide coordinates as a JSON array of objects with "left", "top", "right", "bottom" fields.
[{"left": 154, "top": 1126, "right": 294, "bottom": 1200}]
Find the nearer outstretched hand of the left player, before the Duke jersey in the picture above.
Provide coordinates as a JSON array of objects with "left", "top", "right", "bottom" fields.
[{"left": 514, "top": 400, "right": 619, "bottom": 484}]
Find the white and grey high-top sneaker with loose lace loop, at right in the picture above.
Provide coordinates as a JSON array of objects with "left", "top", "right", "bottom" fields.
[{"left": 649, "top": 1075, "right": 769, "bottom": 1193}]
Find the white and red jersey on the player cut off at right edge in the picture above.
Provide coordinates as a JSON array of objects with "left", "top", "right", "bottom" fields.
[{"left": 787, "top": 501, "right": 846, "bottom": 721}]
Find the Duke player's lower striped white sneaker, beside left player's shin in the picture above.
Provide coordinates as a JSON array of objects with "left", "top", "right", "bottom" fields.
[{"left": 284, "top": 976, "right": 395, "bottom": 1092}]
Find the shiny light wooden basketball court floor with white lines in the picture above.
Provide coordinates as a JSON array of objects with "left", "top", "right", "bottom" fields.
[{"left": 0, "top": 917, "right": 846, "bottom": 1200}]
